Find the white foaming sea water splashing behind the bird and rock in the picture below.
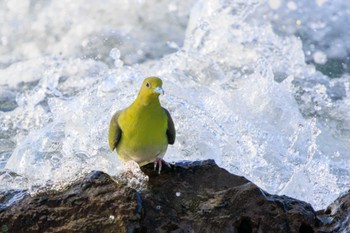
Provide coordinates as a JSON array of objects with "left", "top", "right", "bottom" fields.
[{"left": 0, "top": 0, "right": 350, "bottom": 209}]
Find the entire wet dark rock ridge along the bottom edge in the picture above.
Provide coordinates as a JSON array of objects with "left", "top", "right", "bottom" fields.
[{"left": 0, "top": 160, "right": 350, "bottom": 233}]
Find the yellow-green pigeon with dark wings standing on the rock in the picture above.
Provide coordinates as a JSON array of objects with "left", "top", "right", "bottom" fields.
[{"left": 108, "top": 76, "right": 176, "bottom": 174}]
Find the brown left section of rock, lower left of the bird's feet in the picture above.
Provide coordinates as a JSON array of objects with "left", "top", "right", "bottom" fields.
[{"left": 0, "top": 172, "right": 140, "bottom": 232}]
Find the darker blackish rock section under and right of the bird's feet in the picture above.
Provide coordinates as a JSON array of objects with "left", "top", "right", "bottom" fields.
[{"left": 142, "top": 161, "right": 318, "bottom": 233}]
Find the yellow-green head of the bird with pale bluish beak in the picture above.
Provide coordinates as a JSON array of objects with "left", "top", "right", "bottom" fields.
[{"left": 137, "top": 77, "right": 164, "bottom": 104}]
